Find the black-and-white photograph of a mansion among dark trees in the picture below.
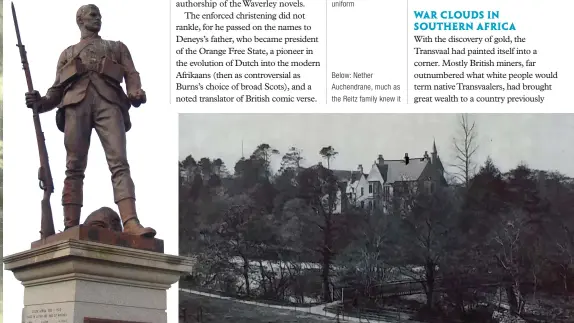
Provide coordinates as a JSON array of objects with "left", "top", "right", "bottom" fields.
[{"left": 179, "top": 114, "right": 574, "bottom": 323}]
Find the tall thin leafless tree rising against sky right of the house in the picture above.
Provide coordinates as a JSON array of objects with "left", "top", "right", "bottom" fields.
[{"left": 452, "top": 114, "right": 478, "bottom": 188}]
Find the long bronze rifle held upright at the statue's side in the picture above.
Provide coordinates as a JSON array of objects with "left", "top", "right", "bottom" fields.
[{"left": 12, "top": 3, "right": 55, "bottom": 239}]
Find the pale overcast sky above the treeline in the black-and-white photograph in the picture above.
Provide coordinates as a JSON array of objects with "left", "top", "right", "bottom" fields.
[{"left": 179, "top": 114, "right": 574, "bottom": 176}]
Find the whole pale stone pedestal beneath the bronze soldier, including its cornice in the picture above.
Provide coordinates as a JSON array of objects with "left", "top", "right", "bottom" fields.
[{"left": 4, "top": 227, "right": 197, "bottom": 323}]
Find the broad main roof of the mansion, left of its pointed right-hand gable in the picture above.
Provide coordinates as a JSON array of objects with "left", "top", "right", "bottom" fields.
[{"left": 377, "top": 158, "right": 428, "bottom": 184}]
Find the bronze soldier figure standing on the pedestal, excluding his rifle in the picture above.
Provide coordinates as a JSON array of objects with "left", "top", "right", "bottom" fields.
[{"left": 26, "top": 4, "right": 156, "bottom": 237}]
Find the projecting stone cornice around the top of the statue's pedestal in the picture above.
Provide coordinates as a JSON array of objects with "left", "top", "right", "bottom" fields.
[{"left": 4, "top": 240, "right": 194, "bottom": 289}]
